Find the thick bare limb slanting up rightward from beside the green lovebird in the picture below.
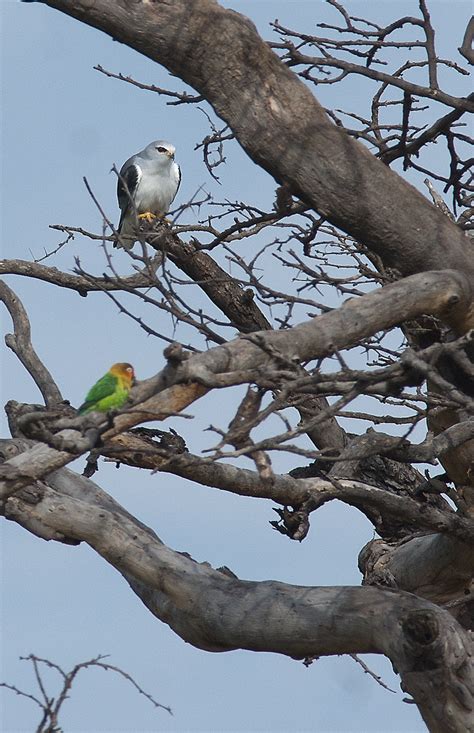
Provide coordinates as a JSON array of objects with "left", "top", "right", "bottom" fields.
[{"left": 110, "top": 271, "right": 470, "bottom": 439}]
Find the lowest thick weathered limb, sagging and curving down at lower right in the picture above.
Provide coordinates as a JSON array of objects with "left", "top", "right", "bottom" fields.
[{"left": 1, "top": 472, "right": 474, "bottom": 733}]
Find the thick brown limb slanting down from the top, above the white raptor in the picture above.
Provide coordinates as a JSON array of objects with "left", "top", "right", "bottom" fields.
[{"left": 35, "top": 0, "right": 474, "bottom": 331}]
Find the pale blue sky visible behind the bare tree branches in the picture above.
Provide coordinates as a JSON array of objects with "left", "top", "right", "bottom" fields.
[{"left": 0, "top": 0, "right": 471, "bottom": 733}]
